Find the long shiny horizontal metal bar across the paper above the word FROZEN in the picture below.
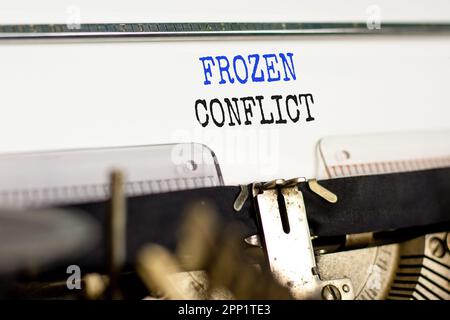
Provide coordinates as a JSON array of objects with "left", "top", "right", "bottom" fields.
[{"left": 0, "top": 22, "right": 450, "bottom": 40}]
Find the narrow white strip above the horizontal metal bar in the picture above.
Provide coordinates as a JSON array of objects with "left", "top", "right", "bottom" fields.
[{"left": 0, "top": 0, "right": 450, "bottom": 24}]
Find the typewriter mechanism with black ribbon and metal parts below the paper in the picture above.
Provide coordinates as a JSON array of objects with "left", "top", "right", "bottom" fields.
[{"left": 0, "top": 141, "right": 450, "bottom": 300}]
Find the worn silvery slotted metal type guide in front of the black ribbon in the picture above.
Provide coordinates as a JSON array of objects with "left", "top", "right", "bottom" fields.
[{"left": 256, "top": 187, "right": 354, "bottom": 300}]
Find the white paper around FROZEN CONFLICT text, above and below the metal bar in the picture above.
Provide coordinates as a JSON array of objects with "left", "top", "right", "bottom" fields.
[{"left": 0, "top": 0, "right": 450, "bottom": 184}]
